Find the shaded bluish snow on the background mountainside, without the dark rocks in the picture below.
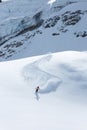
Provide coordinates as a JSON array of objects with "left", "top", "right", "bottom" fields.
[{"left": 0, "top": 0, "right": 87, "bottom": 61}]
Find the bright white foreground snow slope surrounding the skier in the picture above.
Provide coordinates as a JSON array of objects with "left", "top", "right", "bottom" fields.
[{"left": 0, "top": 51, "right": 87, "bottom": 130}]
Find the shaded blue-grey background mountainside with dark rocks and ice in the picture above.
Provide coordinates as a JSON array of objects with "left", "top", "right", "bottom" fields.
[{"left": 0, "top": 0, "right": 87, "bottom": 61}]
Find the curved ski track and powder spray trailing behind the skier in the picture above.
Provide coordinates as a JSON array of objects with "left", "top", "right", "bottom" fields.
[{"left": 23, "top": 55, "right": 62, "bottom": 94}]
